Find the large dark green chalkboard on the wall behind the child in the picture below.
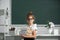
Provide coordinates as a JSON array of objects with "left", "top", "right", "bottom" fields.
[{"left": 12, "top": 0, "right": 60, "bottom": 24}]
